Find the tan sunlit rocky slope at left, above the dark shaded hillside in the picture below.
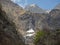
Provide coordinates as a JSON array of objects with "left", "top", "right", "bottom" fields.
[{"left": 0, "top": 0, "right": 25, "bottom": 35}]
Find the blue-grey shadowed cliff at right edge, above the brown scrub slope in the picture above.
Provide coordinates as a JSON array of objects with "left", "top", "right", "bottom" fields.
[{"left": 48, "top": 9, "right": 60, "bottom": 29}]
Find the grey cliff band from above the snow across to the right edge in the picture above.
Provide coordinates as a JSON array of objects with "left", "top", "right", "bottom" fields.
[{"left": 18, "top": 5, "right": 60, "bottom": 30}]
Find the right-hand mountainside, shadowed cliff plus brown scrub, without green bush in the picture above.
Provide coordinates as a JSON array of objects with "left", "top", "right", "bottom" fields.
[{"left": 35, "top": 9, "right": 60, "bottom": 45}]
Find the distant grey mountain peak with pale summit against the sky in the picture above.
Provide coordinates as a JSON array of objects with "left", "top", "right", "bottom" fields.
[{"left": 25, "top": 4, "right": 46, "bottom": 13}]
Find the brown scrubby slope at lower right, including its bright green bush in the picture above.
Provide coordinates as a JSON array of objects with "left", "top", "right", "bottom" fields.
[{"left": 34, "top": 29, "right": 60, "bottom": 45}]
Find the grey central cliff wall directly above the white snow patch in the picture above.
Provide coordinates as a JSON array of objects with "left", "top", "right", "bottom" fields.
[{"left": 18, "top": 12, "right": 48, "bottom": 31}]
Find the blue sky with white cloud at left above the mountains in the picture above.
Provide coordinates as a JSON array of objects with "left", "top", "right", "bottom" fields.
[{"left": 12, "top": 0, "right": 60, "bottom": 10}]
